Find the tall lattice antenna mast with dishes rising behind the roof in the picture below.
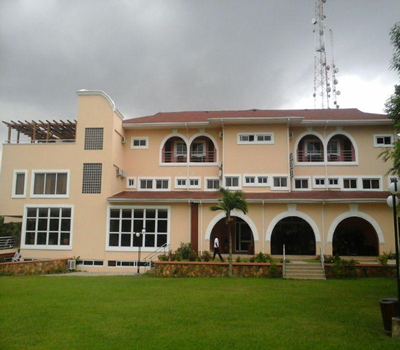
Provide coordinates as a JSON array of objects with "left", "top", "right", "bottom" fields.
[{"left": 311, "top": 0, "right": 340, "bottom": 109}]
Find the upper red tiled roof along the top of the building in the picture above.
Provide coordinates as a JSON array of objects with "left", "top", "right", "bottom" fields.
[{"left": 124, "top": 108, "right": 388, "bottom": 124}]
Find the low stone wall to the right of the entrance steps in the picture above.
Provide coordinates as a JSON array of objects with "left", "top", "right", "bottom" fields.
[{"left": 325, "top": 264, "right": 396, "bottom": 278}]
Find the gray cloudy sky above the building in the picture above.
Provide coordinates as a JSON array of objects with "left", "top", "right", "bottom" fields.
[{"left": 0, "top": 0, "right": 400, "bottom": 163}]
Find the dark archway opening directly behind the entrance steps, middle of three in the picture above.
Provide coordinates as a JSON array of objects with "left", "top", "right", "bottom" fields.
[{"left": 271, "top": 216, "right": 316, "bottom": 255}]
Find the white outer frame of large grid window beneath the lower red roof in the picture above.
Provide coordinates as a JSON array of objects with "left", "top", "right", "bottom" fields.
[{"left": 105, "top": 205, "right": 172, "bottom": 252}]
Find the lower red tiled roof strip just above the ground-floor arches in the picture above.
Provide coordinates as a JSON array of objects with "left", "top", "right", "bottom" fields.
[{"left": 109, "top": 191, "right": 390, "bottom": 202}]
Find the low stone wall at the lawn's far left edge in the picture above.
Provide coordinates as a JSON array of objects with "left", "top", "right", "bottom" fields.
[{"left": 0, "top": 259, "right": 68, "bottom": 276}]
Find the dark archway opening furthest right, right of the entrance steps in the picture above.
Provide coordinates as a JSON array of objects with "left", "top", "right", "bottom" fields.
[{"left": 332, "top": 217, "right": 379, "bottom": 256}]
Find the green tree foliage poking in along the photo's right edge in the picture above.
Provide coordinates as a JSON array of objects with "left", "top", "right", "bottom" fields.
[{"left": 379, "top": 22, "right": 400, "bottom": 176}]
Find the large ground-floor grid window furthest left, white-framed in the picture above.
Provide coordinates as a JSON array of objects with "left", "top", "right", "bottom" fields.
[{"left": 23, "top": 207, "right": 72, "bottom": 249}]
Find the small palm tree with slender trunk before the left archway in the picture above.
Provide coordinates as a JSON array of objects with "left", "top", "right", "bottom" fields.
[{"left": 210, "top": 187, "right": 248, "bottom": 277}]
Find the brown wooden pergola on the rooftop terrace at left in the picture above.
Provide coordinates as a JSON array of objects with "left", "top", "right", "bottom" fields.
[{"left": 3, "top": 120, "right": 77, "bottom": 143}]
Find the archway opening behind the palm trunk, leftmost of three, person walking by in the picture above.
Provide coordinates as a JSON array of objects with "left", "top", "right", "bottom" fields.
[{"left": 210, "top": 217, "right": 254, "bottom": 254}]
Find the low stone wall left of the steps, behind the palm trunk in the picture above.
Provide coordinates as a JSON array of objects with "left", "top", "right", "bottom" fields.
[{"left": 154, "top": 261, "right": 282, "bottom": 277}]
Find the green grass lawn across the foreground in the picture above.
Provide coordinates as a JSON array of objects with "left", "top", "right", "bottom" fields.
[{"left": 0, "top": 276, "right": 400, "bottom": 350}]
